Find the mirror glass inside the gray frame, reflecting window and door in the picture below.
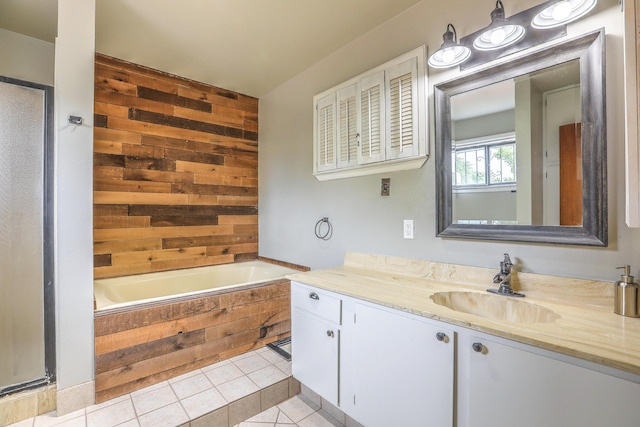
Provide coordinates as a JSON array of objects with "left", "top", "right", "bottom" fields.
[{"left": 450, "top": 59, "right": 583, "bottom": 226}]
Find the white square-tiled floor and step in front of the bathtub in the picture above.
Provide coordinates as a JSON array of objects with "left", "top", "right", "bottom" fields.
[{"left": 10, "top": 347, "right": 341, "bottom": 427}]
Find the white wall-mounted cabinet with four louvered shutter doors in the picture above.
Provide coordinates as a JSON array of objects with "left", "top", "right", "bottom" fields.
[{"left": 313, "top": 46, "right": 428, "bottom": 181}]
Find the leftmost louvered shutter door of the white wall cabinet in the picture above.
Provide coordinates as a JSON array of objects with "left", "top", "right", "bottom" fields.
[{"left": 314, "top": 94, "right": 336, "bottom": 172}]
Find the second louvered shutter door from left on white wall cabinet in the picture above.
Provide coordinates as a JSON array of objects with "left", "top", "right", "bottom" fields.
[{"left": 338, "top": 85, "right": 358, "bottom": 168}]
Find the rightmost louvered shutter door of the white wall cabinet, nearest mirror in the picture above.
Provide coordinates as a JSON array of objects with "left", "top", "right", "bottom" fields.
[{"left": 385, "top": 58, "right": 419, "bottom": 160}]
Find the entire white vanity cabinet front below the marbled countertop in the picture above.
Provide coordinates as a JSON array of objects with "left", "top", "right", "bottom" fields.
[{"left": 291, "top": 282, "right": 640, "bottom": 427}]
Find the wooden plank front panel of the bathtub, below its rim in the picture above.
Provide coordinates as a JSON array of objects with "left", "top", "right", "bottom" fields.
[{"left": 94, "top": 279, "right": 291, "bottom": 403}]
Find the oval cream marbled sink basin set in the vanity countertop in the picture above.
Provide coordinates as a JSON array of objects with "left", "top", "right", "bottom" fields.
[{"left": 431, "top": 292, "right": 560, "bottom": 323}]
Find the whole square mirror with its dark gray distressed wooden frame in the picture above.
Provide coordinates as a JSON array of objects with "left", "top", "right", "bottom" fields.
[{"left": 434, "top": 30, "right": 607, "bottom": 246}]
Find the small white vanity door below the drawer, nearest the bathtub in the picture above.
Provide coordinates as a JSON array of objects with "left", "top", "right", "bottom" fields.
[{"left": 291, "top": 306, "right": 340, "bottom": 406}]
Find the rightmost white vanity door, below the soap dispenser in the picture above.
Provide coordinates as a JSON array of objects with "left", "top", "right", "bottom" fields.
[{"left": 458, "top": 335, "right": 640, "bottom": 427}]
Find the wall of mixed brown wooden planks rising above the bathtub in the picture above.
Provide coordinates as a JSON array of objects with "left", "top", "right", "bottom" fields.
[{"left": 94, "top": 54, "right": 258, "bottom": 278}]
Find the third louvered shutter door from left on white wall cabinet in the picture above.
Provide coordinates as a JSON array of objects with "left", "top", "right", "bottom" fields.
[{"left": 358, "top": 71, "right": 385, "bottom": 164}]
